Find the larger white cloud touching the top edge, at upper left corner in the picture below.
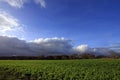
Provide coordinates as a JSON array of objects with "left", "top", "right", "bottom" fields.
[{"left": 0, "top": 0, "right": 27, "bottom": 8}]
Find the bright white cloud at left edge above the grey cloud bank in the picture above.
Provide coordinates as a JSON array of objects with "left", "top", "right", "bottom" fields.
[{"left": 0, "top": 10, "right": 24, "bottom": 36}]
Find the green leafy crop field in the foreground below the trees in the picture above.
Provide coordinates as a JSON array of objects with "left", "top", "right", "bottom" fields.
[{"left": 0, "top": 59, "right": 120, "bottom": 80}]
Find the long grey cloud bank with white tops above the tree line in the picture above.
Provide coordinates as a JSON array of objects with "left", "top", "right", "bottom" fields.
[{"left": 0, "top": 36, "right": 115, "bottom": 56}]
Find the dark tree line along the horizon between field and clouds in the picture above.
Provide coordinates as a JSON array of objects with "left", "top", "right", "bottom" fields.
[{"left": 0, "top": 51, "right": 120, "bottom": 60}]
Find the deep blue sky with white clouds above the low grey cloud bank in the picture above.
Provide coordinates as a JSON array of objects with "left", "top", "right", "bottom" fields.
[{"left": 0, "top": 0, "right": 120, "bottom": 47}]
